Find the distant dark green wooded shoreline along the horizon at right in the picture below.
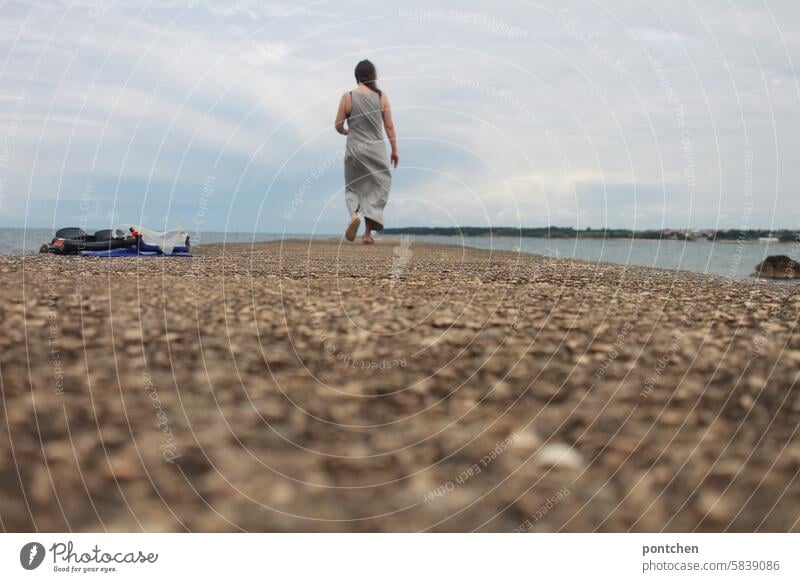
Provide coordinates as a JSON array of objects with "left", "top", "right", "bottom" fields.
[{"left": 383, "top": 226, "right": 800, "bottom": 242}]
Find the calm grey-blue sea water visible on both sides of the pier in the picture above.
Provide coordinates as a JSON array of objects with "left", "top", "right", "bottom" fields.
[{"left": 0, "top": 228, "right": 800, "bottom": 278}]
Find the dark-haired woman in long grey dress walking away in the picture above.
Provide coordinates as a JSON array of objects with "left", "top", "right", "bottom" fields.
[{"left": 336, "top": 60, "right": 400, "bottom": 244}]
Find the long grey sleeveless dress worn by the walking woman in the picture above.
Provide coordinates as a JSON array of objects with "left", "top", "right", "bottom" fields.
[{"left": 344, "top": 91, "right": 392, "bottom": 230}]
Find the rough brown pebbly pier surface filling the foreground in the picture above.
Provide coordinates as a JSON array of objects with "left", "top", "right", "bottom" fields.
[{"left": 0, "top": 239, "right": 800, "bottom": 532}]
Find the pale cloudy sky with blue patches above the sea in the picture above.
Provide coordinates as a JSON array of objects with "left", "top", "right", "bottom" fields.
[{"left": 0, "top": 0, "right": 800, "bottom": 232}]
